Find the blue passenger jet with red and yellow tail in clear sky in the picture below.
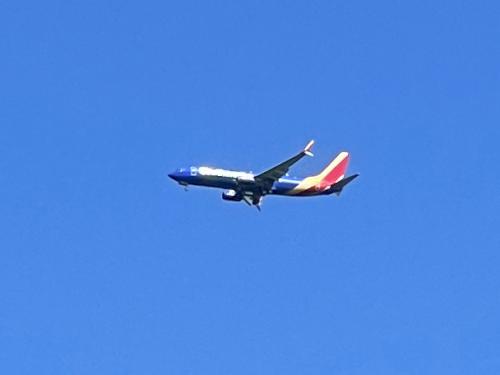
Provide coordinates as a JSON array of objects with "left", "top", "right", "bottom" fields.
[{"left": 168, "top": 141, "right": 359, "bottom": 211}]
